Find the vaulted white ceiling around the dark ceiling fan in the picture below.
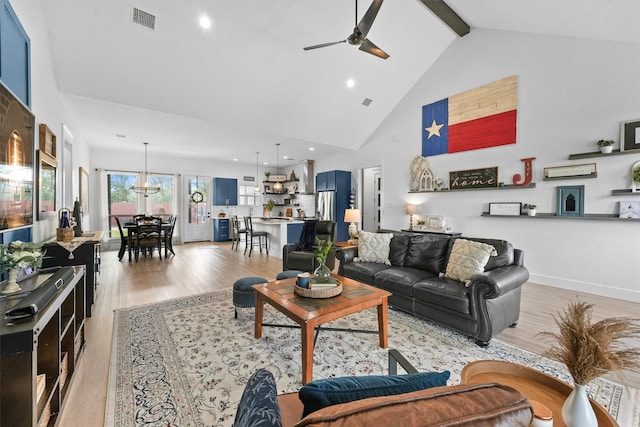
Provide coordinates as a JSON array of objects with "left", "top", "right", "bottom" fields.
[{"left": 41, "top": 0, "right": 640, "bottom": 163}]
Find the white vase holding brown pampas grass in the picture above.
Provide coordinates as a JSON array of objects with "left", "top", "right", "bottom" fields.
[{"left": 538, "top": 302, "right": 640, "bottom": 427}]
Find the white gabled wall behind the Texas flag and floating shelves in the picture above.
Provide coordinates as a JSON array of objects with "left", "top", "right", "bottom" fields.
[{"left": 324, "top": 29, "right": 640, "bottom": 302}]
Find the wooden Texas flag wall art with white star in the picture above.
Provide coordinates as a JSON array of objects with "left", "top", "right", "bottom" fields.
[{"left": 422, "top": 76, "right": 518, "bottom": 156}]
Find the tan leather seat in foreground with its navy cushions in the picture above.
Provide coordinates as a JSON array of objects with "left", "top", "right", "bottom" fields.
[{"left": 233, "top": 350, "right": 533, "bottom": 427}]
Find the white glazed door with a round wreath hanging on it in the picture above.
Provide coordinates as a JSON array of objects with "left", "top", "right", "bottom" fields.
[{"left": 183, "top": 176, "right": 213, "bottom": 242}]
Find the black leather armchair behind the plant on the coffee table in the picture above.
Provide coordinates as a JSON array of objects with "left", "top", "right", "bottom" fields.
[{"left": 282, "top": 220, "right": 336, "bottom": 272}]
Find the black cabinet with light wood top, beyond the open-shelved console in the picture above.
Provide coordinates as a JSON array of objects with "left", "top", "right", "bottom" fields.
[{"left": 42, "top": 231, "right": 102, "bottom": 317}]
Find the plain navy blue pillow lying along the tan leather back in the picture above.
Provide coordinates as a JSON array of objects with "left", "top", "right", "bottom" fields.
[{"left": 298, "top": 371, "right": 451, "bottom": 417}]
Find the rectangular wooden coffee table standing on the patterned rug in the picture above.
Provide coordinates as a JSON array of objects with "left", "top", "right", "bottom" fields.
[{"left": 253, "top": 275, "right": 391, "bottom": 384}]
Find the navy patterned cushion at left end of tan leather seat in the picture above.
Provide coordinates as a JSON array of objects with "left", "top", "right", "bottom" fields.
[{"left": 233, "top": 369, "right": 282, "bottom": 427}]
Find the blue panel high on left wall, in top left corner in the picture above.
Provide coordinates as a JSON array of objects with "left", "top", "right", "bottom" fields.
[{"left": 0, "top": 0, "right": 31, "bottom": 107}]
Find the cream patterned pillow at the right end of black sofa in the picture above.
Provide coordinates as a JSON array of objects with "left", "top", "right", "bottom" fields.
[{"left": 444, "top": 239, "right": 498, "bottom": 282}]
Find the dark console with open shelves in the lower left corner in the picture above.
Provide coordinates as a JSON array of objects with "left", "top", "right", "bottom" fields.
[{"left": 0, "top": 267, "right": 86, "bottom": 427}]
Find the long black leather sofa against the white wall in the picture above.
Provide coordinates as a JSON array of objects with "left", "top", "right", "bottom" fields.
[{"left": 336, "top": 230, "right": 529, "bottom": 346}]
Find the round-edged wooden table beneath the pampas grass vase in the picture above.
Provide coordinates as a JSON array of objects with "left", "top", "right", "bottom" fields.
[{"left": 461, "top": 360, "right": 618, "bottom": 427}]
